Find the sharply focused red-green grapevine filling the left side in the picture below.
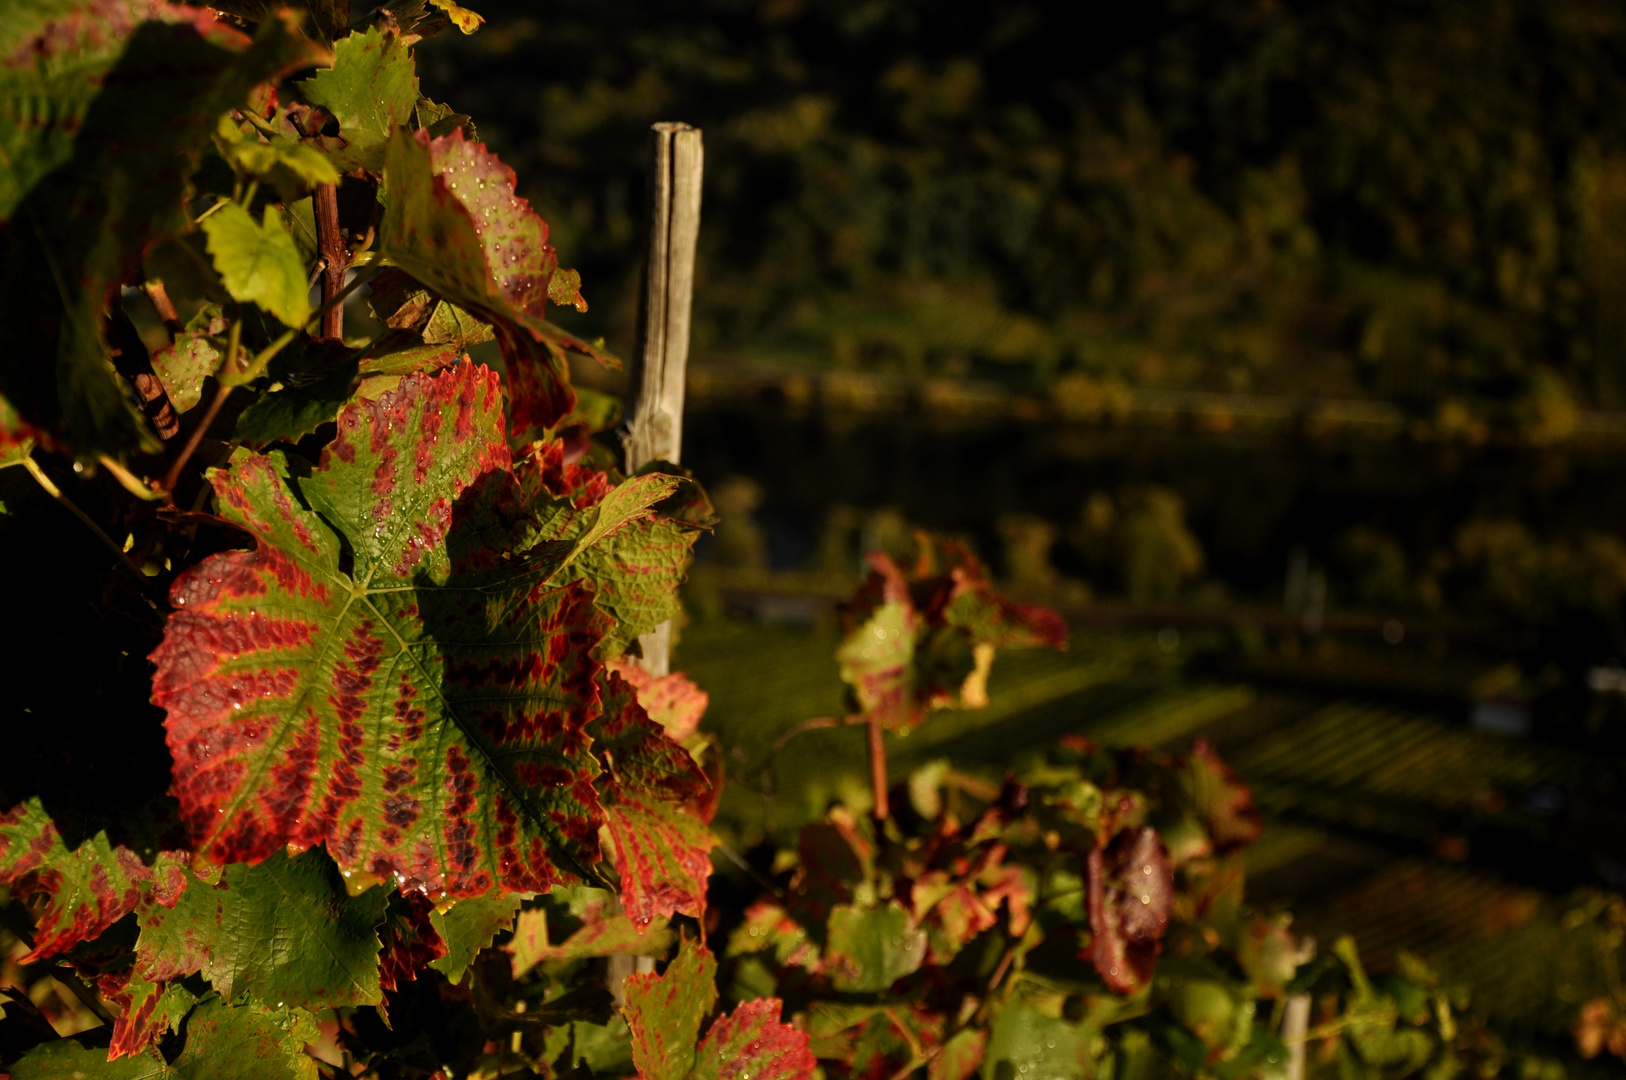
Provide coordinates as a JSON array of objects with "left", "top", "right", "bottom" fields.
[{"left": 0, "top": 0, "right": 811, "bottom": 1080}]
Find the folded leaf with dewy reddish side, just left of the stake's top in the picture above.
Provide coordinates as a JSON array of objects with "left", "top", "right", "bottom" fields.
[{"left": 379, "top": 128, "right": 603, "bottom": 433}]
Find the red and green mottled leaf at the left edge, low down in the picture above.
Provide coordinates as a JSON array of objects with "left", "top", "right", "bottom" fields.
[{"left": 0, "top": 797, "right": 189, "bottom": 963}]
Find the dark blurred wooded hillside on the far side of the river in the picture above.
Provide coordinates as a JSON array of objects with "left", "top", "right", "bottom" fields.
[{"left": 424, "top": 0, "right": 1626, "bottom": 415}]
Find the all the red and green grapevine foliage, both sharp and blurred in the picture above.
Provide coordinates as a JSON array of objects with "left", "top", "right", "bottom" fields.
[{"left": 0, "top": 0, "right": 1599, "bottom": 1080}]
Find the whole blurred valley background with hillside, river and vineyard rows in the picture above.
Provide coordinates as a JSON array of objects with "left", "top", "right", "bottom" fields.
[{"left": 409, "top": 0, "right": 1626, "bottom": 1073}]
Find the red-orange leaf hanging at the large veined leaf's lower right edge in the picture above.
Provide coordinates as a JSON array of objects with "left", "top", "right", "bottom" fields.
[{"left": 587, "top": 673, "right": 715, "bottom": 927}]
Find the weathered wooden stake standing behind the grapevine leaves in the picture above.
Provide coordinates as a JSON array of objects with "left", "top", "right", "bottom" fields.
[{"left": 606, "top": 122, "right": 706, "bottom": 1007}]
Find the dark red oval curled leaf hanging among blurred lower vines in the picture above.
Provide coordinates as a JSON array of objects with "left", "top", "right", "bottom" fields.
[{"left": 1086, "top": 828, "right": 1174, "bottom": 994}]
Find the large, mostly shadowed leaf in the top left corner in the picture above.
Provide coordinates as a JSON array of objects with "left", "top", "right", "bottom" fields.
[{"left": 0, "top": 0, "right": 324, "bottom": 455}]
